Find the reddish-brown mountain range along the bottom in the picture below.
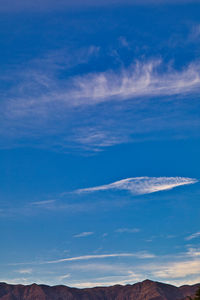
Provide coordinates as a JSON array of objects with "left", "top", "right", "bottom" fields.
[{"left": 0, "top": 280, "right": 200, "bottom": 300}]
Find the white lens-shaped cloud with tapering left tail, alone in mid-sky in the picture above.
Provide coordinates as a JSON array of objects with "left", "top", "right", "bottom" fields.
[{"left": 76, "top": 177, "right": 198, "bottom": 195}]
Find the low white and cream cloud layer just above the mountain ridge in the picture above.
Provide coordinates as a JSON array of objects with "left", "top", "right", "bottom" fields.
[{"left": 7, "top": 248, "right": 200, "bottom": 287}]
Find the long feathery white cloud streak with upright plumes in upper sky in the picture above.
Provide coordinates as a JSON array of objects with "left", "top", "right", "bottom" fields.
[{"left": 5, "top": 60, "right": 200, "bottom": 118}]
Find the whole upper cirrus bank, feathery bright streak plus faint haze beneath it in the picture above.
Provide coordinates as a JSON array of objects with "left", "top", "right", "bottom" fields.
[{"left": 0, "top": 57, "right": 200, "bottom": 151}]
